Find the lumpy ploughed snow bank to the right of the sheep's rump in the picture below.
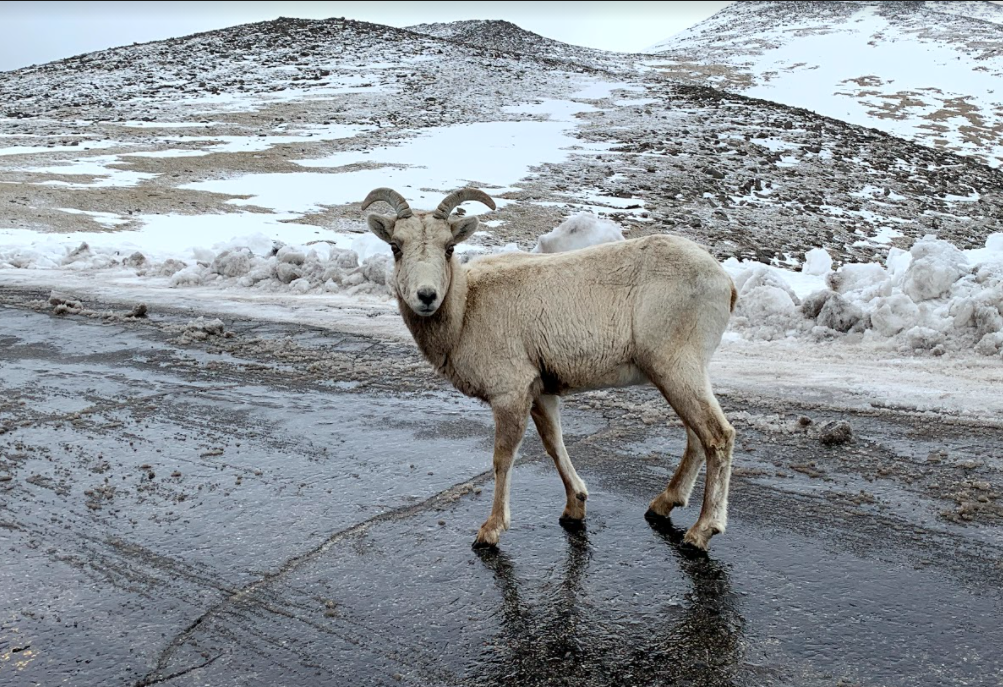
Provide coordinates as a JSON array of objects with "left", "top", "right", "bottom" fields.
[{"left": 724, "top": 234, "right": 1003, "bottom": 355}]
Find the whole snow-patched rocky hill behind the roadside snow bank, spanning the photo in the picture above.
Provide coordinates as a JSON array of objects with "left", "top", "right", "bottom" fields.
[{"left": 0, "top": 12, "right": 1003, "bottom": 266}]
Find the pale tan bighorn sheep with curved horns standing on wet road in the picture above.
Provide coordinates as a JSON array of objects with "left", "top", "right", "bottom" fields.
[{"left": 362, "top": 189, "right": 737, "bottom": 549}]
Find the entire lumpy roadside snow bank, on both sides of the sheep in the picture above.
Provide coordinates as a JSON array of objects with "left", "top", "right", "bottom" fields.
[{"left": 0, "top": 207, "right": 1003, "bottom": 356}]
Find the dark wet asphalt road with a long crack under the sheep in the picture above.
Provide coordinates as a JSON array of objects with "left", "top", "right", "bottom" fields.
[{"left": 0, "top": 298, "right": 1003, "bottom": 687}]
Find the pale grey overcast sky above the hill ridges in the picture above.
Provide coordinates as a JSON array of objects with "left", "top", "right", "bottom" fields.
[{"left": 0, "top": 0, "right": 731, "bottom": 71}]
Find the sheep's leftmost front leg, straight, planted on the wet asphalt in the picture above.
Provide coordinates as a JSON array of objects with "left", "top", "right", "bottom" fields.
[{"left": 473, "top": 398, "right": 530, "bottom": 547}]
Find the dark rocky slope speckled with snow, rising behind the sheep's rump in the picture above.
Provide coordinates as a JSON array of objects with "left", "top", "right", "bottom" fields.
[{"left": 565, "top": 82, "right": 1003, "bottom": 265}]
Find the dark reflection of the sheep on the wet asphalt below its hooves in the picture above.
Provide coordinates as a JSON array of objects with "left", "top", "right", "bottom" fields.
[{"left": 475, "top": 519, "right": 744, "bottom": 685}]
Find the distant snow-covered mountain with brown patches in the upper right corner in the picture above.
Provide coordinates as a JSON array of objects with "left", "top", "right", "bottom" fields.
[{"left": 649, "top": 1, "right": 1003, "bottom": 166}]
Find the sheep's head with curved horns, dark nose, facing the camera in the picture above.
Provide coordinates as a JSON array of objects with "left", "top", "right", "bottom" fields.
[{"left": 362, "top": 189, "right": 494, "bottom": 317}]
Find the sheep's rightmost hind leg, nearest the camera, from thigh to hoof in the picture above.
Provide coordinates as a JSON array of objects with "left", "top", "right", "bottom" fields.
[{"left": 648, "top": 359, "right": 735, "bottom": 551}]
